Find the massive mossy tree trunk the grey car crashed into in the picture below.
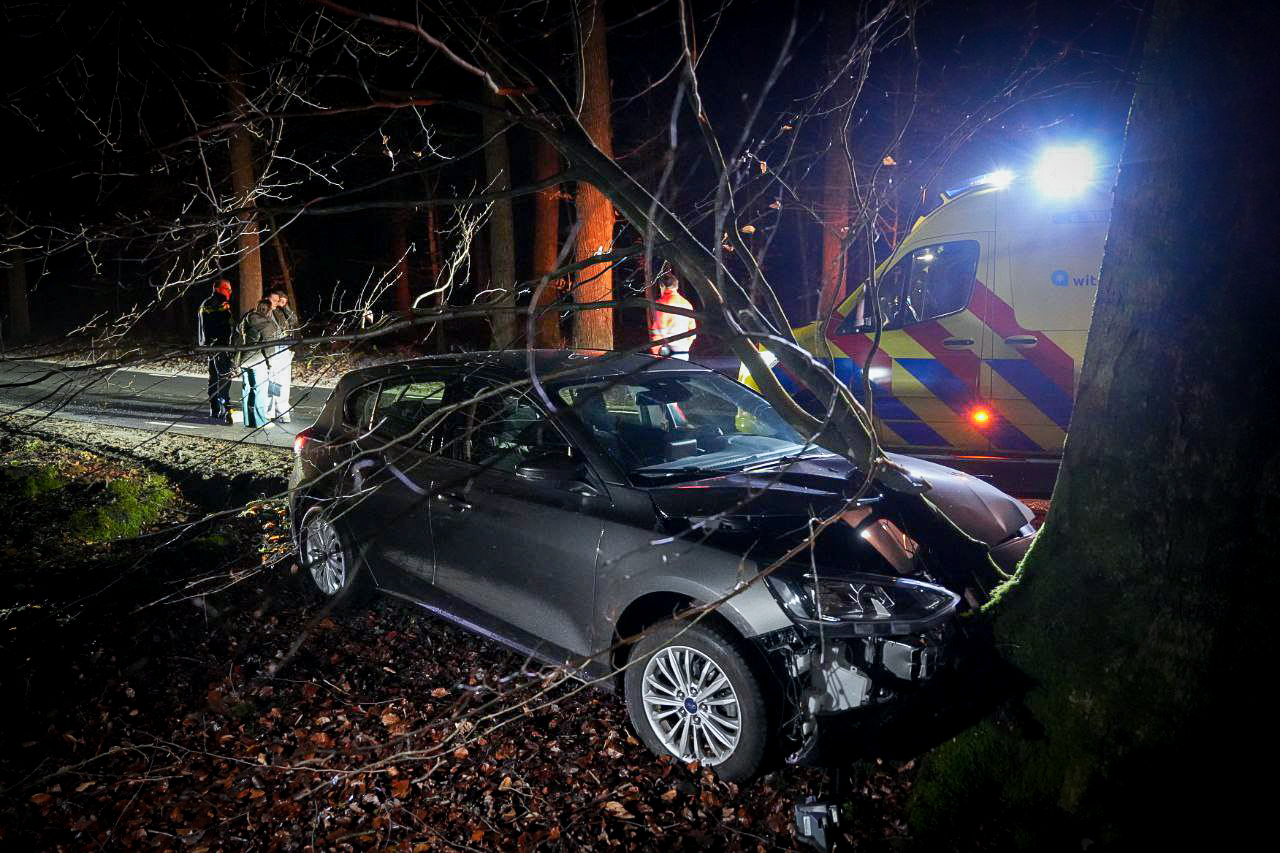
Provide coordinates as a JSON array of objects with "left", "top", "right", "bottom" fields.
[{"left": 911, "top": 0, "right": 1280, "bottom": 850}]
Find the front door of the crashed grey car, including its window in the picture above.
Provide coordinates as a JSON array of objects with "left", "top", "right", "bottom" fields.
[{"left": 431, "top": 388, "right": 608, "bottom": 658}]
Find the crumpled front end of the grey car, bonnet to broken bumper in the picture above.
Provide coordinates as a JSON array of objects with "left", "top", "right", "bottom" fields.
[{"left": 650, "top": 450, "right": 1034, "bottom": 765}]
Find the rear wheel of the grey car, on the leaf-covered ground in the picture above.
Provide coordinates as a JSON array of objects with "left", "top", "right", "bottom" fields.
[{"left": 298, "top": 503, "right": 372, "bottom": 607}]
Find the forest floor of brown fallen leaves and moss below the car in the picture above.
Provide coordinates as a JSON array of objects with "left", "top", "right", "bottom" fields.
[{"left": 0, "top": 420, "right": 914, "bottom": 850}]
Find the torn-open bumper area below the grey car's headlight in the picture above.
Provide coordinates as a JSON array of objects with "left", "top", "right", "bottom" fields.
[{"left": 758, "top": 622, "right": 956, "bottom": 766}]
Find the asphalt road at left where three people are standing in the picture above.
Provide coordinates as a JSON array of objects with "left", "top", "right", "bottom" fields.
[{"left": 0, "top": 360, "right": 330, "bottom": 447}]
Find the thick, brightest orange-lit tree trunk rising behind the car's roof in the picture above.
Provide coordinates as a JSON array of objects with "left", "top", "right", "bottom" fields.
[{"left": 573, "top": 0, "right": 613, "bottom": 350}]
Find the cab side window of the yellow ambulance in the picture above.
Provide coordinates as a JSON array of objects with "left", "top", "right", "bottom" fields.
[{"left": 836, "top": 240, "right": 979, "bottom": 334}]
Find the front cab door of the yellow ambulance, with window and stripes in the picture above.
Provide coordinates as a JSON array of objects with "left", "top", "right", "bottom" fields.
[{"left": 832, "top": 232, "right": 992, "bottom": 453}]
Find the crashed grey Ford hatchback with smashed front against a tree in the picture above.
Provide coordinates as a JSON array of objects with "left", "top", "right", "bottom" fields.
[{"left": 291, "top": 351, "right": 1034, "bottom": 779}]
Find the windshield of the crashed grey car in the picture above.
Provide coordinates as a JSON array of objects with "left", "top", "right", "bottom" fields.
[{"left": 556, "top": 371, "right": 824, "bottom": 482}]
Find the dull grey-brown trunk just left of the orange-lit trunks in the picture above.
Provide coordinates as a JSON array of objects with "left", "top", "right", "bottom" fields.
[{"left": 483, "top": 92, "right": 516, "bottom": 350}]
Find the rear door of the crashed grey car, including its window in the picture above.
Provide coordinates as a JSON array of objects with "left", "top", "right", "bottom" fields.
[{"left": 348, "top": 368, "right": 461, "bottom": 594}]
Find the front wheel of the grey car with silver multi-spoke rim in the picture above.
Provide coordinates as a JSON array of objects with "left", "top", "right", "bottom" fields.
[{"left": 623, "top": 620, "right": 772, "bottom": 781}]
